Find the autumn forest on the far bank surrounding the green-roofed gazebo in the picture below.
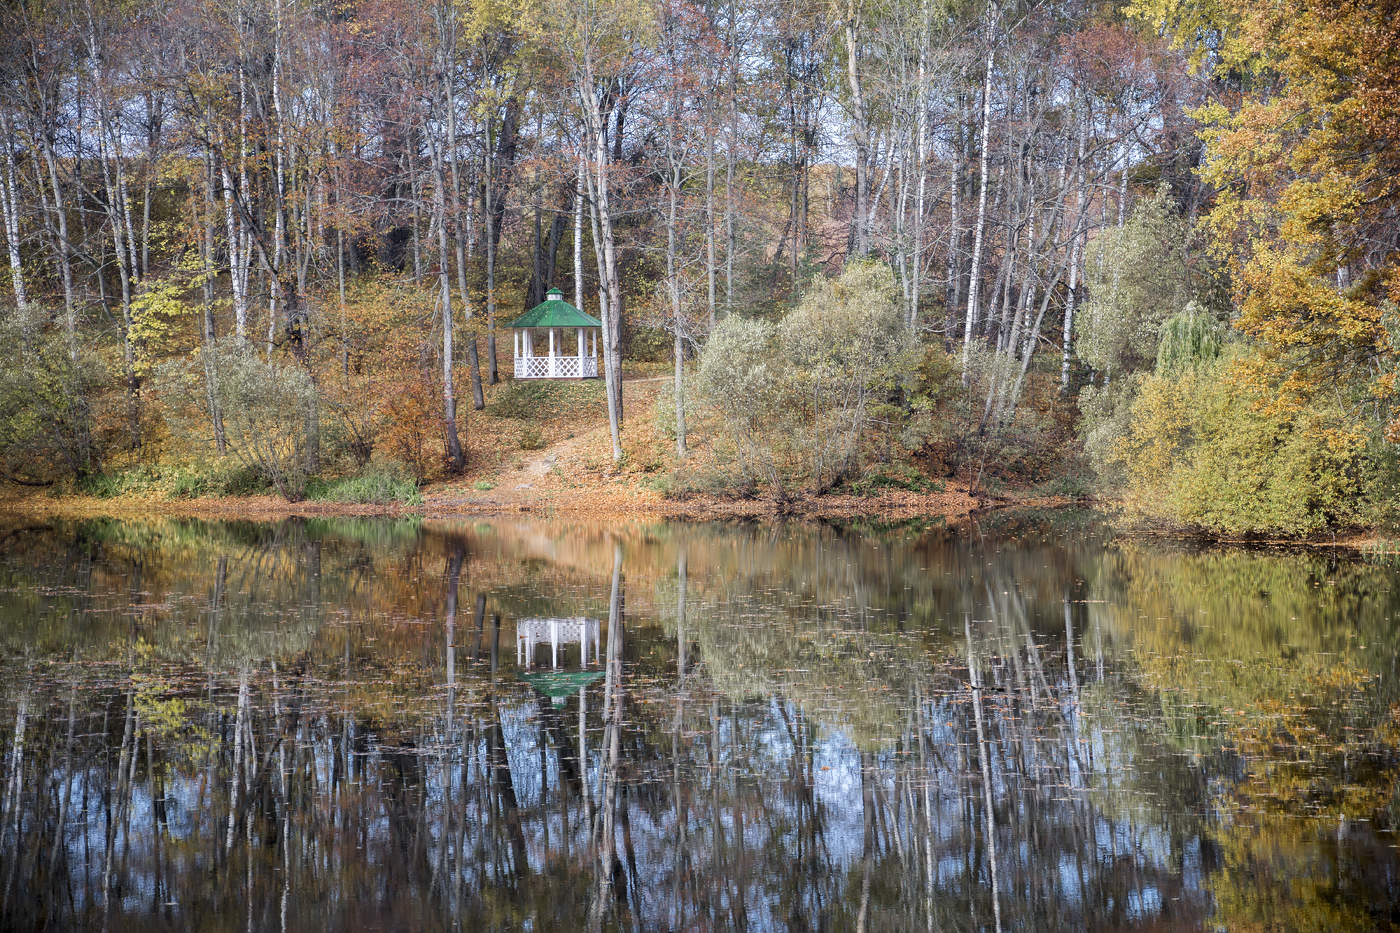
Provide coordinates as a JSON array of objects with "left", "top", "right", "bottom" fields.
[{"left": 0, "top": 0, "right": 1400, "bottom": 537}]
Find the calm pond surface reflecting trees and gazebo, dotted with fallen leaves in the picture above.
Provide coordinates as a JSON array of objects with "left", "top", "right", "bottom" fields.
[{"left": 0, "top": 513, "right": 1400, "bottom": 933}]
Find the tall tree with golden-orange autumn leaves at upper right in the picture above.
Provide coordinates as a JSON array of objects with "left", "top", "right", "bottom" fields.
[{"left": 1127, "top": 0, "right": 1400, "bottom": 431}]
